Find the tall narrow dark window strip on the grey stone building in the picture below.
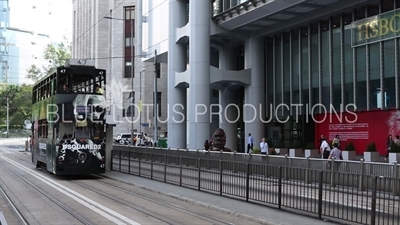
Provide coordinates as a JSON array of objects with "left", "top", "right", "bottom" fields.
[{"left": 124, "top": 6, "right": 135, "bottom": 78}]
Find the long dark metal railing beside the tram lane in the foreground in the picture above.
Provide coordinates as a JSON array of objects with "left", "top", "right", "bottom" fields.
[{"left": 112, "top": 150, "right": 400, "bottom": 224}]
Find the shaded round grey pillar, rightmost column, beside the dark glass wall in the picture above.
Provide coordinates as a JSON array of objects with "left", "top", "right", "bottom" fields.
[{"left": 243, "top": 38, "right": 266, "bottom": 148}]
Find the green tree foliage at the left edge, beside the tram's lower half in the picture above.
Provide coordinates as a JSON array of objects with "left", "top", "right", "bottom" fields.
[{"left": 0, "top": 84, "right": 32, "bottom": 128}]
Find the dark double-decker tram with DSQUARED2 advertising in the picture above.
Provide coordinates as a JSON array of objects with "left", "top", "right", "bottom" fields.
[{"left": 32, "top": 59, "right": 106, "bottom": 175}]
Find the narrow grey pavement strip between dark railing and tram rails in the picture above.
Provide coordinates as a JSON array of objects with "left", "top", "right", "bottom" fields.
[{"left": 104, "top": 171, "right": 344, "bottom": 225}]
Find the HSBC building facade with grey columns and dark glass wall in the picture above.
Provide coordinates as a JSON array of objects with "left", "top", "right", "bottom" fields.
[{"left": 143, "top": 0, "right": 400, "bottom": 151}]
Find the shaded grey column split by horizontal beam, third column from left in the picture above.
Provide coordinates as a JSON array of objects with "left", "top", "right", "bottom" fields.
[{"left": 219, "top": 48, "right": 239, "bottom": 151}]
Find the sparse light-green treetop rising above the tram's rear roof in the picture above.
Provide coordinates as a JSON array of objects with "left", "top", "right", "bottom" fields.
[{"left": 27, "top": 38, "right": 71, "bottom": 82}]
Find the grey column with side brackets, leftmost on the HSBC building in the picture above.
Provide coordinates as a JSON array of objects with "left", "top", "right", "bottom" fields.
[{"left": 168, "top": 0, "right": 187, "bottom": 148}]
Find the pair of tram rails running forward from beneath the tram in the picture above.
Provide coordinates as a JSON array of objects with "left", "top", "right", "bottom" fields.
[{"left": 71, "top": 180, "right": 236, "bottom": 225}]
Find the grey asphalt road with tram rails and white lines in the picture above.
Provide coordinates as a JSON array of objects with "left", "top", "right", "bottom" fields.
[{"left": 0, "top": 139, "right": 344, "bottom": 225}]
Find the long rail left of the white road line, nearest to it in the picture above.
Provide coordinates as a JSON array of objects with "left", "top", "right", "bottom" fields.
[{"left": 3, "top": 165, "right": 92, "bottom": 225}]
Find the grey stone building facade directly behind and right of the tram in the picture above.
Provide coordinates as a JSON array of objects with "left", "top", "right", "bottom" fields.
[{"left": 72, "top": 0, "right": 167, "bottom": 136}]
